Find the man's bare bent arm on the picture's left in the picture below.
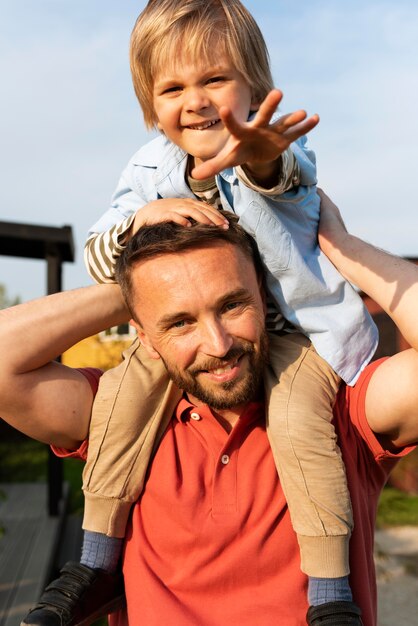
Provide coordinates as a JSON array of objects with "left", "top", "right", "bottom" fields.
[{"left": 0, "top": 285, "right": 129, "bottom": 448}]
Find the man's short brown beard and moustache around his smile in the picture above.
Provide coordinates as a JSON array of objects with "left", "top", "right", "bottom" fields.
[{"left": 163, "top": 331, "right": 268, "bottom": 410}]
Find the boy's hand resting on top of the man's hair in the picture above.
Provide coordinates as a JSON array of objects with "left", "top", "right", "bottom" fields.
[{"left": 131, "top": 198, "right": 229, "bottom": 235}]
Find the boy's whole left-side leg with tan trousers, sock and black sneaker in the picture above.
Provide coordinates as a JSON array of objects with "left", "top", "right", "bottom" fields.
[{"left": 22, "top": 341, "right": 182, "bottom": 626}]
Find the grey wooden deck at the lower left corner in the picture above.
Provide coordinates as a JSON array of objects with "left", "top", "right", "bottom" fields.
[{"left": 0, "top": 483, "right": 77, "bottom": 626}]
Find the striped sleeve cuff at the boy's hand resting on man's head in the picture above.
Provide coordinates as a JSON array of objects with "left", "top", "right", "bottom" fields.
[{"left": 84, "top": 213, "right": 135, "bottom": 283}]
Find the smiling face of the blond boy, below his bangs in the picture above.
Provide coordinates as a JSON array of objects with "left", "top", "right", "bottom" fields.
[{"left": 153, "top": 55, "right": 258, "bottom": 171}]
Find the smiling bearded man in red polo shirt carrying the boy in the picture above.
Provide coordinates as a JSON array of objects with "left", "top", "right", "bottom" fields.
[{"left": 0, "top": 191, "right": 418, "bottom": 626}]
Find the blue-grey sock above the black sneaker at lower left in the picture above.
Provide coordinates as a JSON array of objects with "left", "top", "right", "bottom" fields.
[{"left": 80, "top": 530, "right": 123, "bottom": 573}]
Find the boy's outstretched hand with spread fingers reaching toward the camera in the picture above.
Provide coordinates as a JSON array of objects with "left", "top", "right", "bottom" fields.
[{"left": 192, "top": 89, "right": 319, "bottom": 183}]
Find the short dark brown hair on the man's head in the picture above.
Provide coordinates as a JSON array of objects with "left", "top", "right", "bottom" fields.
[{"left": 115, "top": 211, "right": 264, "bottom": 321}]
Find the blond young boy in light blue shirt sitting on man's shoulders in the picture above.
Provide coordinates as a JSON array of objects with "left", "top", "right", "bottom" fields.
[{"left": 24, "top": 0, "right": 377, "bottom": 624}]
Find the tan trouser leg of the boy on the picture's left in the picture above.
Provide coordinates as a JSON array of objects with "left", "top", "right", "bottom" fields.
[{"left": 83, "top": 340, "right": 182, "bottom": 538}]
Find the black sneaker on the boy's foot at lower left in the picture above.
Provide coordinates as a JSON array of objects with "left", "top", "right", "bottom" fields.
[{"left": 21, "top": 562, "right": 125, "bottom": 626}]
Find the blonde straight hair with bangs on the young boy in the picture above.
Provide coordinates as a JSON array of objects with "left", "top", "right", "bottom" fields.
[{"left": 130, "top": 0, "right": 273, "bottom": 128}]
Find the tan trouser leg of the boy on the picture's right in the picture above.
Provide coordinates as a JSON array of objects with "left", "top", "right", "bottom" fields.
[{"left": 267, "top": 333, "right": 353, "bottom": 596}]
